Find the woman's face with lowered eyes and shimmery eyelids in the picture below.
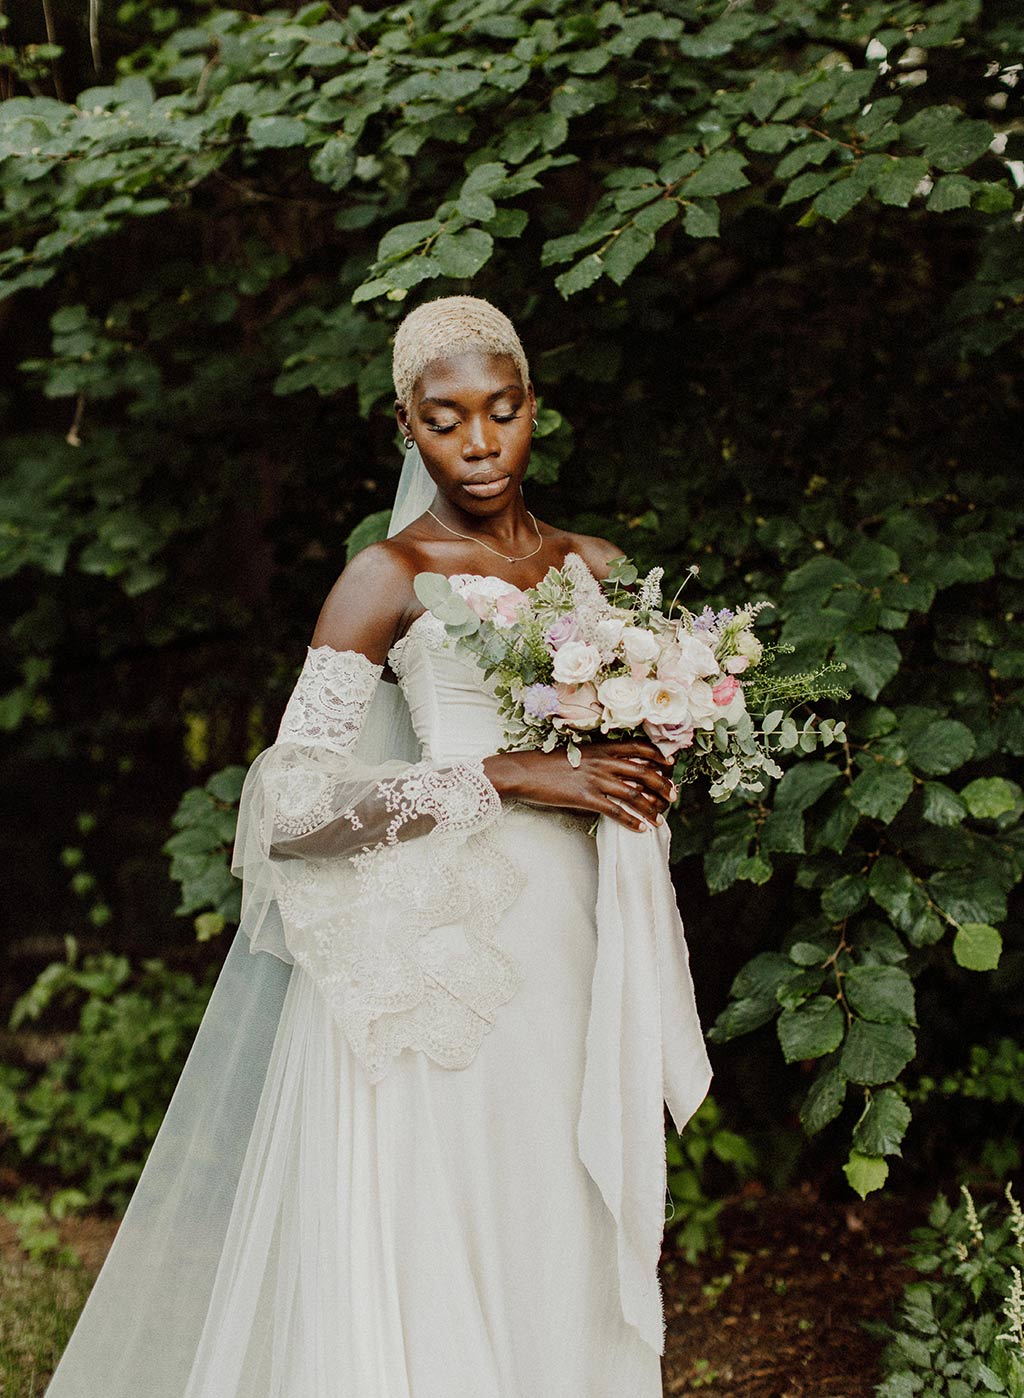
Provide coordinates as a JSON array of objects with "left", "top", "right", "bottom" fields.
[{"left": 396, "top": 350, "right": 536, "bottom": 517}]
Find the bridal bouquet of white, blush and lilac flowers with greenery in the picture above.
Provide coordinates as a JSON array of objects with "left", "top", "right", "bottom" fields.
[{"left": 414, "top": 554, "right": 849, "bottom": 801}]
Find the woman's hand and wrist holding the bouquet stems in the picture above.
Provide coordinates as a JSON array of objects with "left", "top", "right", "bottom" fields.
[{"left": 483, "top": 738, "right": 676, "bottom": 830}]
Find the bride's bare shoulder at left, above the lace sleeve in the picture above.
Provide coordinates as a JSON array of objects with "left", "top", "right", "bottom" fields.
[{"left": 311, "top": 540, "right": 415, "bottom": 664}]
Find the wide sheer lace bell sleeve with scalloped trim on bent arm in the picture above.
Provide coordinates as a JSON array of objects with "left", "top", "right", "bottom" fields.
[{"left": 231, "top": 646, "right": 520, "bottom": 1081}]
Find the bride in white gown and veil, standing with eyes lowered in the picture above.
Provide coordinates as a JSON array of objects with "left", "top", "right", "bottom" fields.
[{"left": 48, "top": 296, "right": 711, "bottom": 1398}]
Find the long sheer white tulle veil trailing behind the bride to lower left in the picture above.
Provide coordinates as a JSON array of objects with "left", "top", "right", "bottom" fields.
[{"left": 46, "top": 445, "right": 435, "bottom": 1398}]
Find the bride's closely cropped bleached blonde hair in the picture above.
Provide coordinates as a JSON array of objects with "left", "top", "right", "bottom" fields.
[{"left": 392, "top": 296, "right": 530, "bottom": 407}]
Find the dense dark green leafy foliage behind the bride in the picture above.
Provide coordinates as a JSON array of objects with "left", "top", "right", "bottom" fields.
[{"left": 0, "top": 0, "right": 1024, "bottom": 1224}]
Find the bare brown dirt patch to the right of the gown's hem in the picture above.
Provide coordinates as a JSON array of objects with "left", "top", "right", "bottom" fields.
[{"left": 662, "top": 1186, "right": 932, "bottom": 1398}]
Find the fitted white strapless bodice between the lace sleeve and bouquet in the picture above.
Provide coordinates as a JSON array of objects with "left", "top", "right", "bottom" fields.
[{"left": 387, "top": 601, "right": 505, "bottom": 765}]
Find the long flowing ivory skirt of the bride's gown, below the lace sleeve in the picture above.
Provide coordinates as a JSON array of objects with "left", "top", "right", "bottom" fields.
[{"left": 183, "top": 808, "right": 662, "bottom": 1398}]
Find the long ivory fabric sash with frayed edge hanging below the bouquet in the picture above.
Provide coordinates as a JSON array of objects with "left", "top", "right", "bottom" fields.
[{"left": 578, "top": 815, "right": 712, "bottom": 1355}]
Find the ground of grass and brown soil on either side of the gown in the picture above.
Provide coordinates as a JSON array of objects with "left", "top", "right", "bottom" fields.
[{"left": 0, "top": 1186, "right": 930, "bottom": 1398}]
